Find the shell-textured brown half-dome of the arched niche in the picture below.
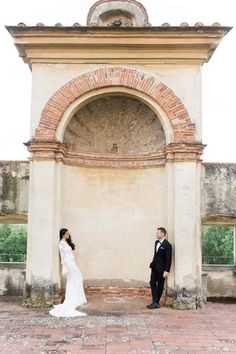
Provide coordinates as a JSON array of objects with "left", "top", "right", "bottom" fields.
[{"left": 63, "top": 94, "right": 166, "bottom": 156}]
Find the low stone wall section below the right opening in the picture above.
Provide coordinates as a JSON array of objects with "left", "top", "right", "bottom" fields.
[{"left": 204, "top": 266, "right": 236, "bottom": 298}]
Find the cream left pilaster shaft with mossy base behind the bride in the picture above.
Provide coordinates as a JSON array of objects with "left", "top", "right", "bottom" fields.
[{"left": 24, "top": 155, "right": 62, "bottom": 307}]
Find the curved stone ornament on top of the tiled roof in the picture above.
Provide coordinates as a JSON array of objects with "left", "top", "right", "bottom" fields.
[{"left": 87, "top": 0, "right": 149, "bottom": 27}]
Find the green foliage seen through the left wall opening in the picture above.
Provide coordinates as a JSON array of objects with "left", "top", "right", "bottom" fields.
[{"left": 0, "top": 224, "right": 27, "bottom": 262}]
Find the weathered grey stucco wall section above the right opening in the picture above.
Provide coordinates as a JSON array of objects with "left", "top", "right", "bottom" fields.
[{"left": 201, "top": 163, "right": 236, "bottom": 224}]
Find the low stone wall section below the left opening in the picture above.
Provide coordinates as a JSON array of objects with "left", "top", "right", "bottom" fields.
[{"left": 0, "top": 263, "right": 25, "bottom": 296}]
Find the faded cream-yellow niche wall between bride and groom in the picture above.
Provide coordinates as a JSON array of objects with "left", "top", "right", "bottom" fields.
[{"left": 61, "top": 166, "right": 167, "bottom": 285}]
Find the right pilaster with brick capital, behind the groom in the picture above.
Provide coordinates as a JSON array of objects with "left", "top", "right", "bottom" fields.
[{"left": 166, "top": 144, "right": 204, "bottom": 309}]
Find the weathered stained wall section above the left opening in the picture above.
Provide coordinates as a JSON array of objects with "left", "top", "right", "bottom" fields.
[{"left": 0, "top": 161, "right": 29, "bottom": 223}]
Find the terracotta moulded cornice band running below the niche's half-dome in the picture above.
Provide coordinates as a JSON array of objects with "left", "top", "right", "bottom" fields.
[{"left": 25, "top": 141, "right": 205, "bottom": 168}]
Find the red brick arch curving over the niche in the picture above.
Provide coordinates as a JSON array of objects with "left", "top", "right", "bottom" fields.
[{"left": 35, "top": 67, "right": 195, "bottom": 142}]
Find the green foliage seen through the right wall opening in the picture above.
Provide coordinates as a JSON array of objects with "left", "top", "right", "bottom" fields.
[{"left": 202, "top": 226, "right": 234, "bottom": 265}]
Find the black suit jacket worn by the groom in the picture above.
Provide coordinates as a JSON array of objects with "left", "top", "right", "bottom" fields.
[{"left": 150, "top": 239, "right": 172, "bottom": 272}]
